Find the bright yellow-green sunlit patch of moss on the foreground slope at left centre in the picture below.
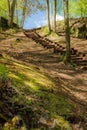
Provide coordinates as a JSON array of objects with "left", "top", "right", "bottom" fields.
[{"left": 4, "top": 57, "right": 54, "bottom": 91}]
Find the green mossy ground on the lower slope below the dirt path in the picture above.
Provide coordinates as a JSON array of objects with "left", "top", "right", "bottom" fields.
[{"left": 0, "top": 56, "right": 75, "bottom": 130}]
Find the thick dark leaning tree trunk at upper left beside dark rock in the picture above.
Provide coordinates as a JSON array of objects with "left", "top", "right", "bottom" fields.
[{"left": 8, "top": 0, "right": 16, "bottom": 27}]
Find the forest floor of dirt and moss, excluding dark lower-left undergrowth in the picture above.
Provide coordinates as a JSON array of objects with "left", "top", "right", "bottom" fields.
[{"left": 0, "top": 31, "right": 87, "bottom": 130}]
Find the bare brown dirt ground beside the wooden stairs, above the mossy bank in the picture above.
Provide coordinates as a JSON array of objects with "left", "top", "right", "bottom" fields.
[{"left": 0, "top": 32, "right": 87, "bottom": 129}]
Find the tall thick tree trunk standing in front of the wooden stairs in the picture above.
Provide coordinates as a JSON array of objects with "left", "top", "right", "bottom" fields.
[{"left": 64, "top": 0, "right": 71, "bottom": 62}]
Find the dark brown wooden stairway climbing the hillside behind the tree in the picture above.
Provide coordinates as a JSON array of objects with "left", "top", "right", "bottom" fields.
[{"left": 24, "top": 30, "right": 87, "bottom": 70}]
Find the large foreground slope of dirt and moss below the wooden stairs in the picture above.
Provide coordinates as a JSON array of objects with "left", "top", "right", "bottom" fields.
[{"left": 0, "top": 32, "right": 87, "bottom": 130}]
